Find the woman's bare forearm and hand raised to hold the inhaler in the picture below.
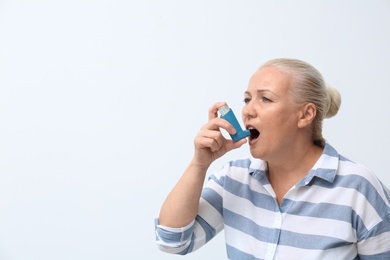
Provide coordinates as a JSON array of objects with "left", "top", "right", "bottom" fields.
[{"left": 159, "top": 102, "right": 246, "bottom": 228}]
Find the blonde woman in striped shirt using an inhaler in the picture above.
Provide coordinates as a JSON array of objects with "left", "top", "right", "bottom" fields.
[{"left": 156, "top": 59, "right": 390, "bottom": 259}]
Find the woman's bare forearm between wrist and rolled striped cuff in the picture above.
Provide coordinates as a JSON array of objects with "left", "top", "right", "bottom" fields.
[{"left": 159, "top": 161, "right": 208, "bottom": 228}]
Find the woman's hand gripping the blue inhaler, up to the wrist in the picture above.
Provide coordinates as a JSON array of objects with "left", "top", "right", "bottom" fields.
[{"left": 192, "top": 102, "right": 246, "bottom": 167}]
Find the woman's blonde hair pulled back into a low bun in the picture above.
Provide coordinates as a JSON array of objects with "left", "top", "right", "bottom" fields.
[{"left": 260, "top": 59, "right": 341, "bottom": 147}]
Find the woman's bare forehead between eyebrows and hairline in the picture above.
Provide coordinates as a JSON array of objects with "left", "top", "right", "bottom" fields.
[{"left": 248, "top": 67, "right": 291, "bottom": 94}]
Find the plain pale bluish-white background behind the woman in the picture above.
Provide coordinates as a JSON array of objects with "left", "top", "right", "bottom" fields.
[{"left": 0, "top": 0, "right": 390, "bottom": 260}]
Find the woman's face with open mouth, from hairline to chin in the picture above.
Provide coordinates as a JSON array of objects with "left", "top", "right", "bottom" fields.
[{"left": 242, "top": 67, "right": 299, "bottom": 161}]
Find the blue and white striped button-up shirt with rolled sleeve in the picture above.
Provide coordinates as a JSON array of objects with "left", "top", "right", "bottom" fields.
[{"left": 155, "top": 144, "right": 390, "bottom": 260}]
